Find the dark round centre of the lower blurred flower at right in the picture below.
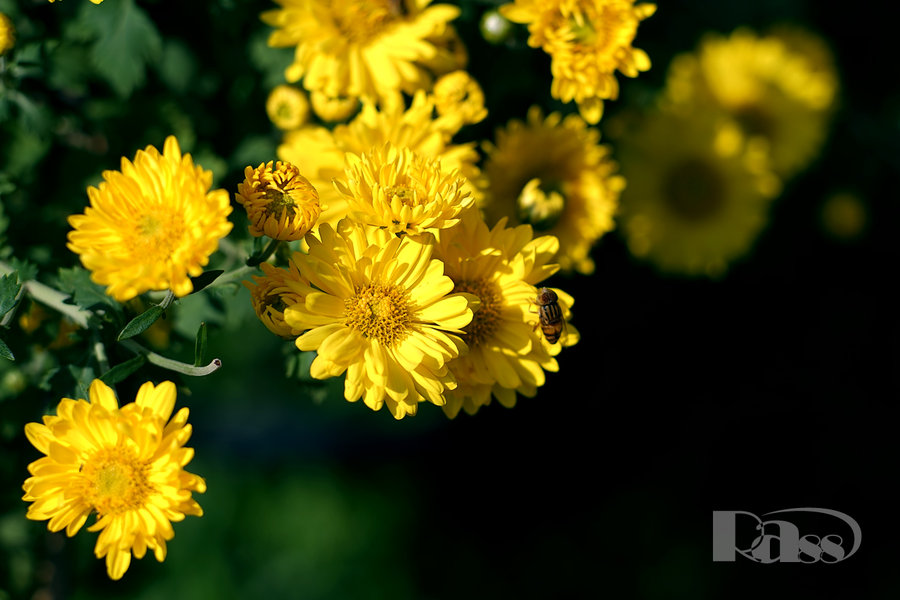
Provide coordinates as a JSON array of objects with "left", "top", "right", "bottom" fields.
[{"left": 663, "top": 159, "right": 725, "bottom": 221}]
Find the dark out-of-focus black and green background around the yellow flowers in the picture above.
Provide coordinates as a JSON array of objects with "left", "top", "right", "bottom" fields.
[{"left": 0, "top": 0, "right": 900, "bottom": 599}]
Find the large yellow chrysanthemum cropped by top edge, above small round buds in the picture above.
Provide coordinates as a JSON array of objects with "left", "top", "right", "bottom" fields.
[{"left": 262, "top": 0, "right": 459, "bottom": 105}]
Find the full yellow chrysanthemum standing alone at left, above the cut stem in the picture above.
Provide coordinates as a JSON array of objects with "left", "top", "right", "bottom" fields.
[{"left": 68, "top": 136, "right": 231, "bottom": 302}]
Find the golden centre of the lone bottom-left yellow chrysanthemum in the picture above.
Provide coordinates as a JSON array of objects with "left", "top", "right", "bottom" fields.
[{"left": 81, "top": 446, "right": 152, "bottom": 516}]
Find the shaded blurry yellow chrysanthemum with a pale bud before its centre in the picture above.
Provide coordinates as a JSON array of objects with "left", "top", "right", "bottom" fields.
[{"left": 483, "top": 107, "right": 625, "bottom": 274}]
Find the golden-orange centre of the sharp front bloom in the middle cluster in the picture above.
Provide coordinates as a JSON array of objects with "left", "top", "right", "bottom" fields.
[{"left": 344, "top": 282, "right": 411, "bottom": 346}]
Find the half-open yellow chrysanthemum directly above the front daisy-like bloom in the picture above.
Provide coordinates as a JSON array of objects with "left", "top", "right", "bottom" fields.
[{"left": 334, "top": 144, "right": 474, "bottom": 235}]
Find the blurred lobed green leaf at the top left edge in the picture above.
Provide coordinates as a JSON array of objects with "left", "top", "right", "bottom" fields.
[{"left": 79, "top": 0, "right": 162, "bottom": 97}]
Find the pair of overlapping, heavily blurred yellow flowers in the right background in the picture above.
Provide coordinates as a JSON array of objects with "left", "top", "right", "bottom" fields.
[{"left": 617, "top": 28, "right": 838, "bottom": 277}]
